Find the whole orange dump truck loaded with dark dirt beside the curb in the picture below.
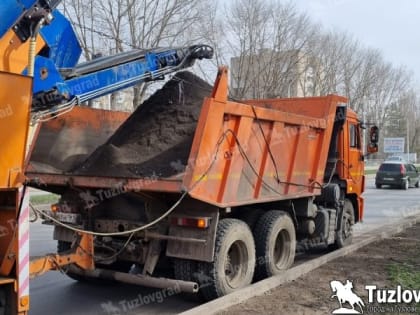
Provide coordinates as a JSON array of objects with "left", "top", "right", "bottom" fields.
[{"left": 26, "top": 68, "right": 377, "bottom": 299}]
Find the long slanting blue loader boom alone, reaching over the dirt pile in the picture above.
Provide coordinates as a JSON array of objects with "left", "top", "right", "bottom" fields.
[{"left": 33, "top": 45, "right": 213, "bottom": 111}]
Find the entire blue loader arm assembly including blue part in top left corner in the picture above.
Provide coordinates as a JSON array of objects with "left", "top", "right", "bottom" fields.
[{"left": 0, "top": 0, "right": 213, "bottom": 115}]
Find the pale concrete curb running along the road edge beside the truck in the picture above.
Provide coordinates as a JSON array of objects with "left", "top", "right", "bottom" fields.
[{"left": 180, "top": 214, "right": 420, "bottom": 315}]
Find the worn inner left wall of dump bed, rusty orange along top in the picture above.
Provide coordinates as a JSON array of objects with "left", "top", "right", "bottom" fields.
[{"left": 27, "top": 106, "right": 130, "bottom": 174}]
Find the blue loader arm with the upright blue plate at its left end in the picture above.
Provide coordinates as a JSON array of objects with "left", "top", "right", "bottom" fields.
[{"left": 32, "top": 10, "right": 213, "bottom": 112}]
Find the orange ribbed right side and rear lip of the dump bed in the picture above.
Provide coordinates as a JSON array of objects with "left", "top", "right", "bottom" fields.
[{"left": 27, "top": 70, "right": 347, "bottom": 207}]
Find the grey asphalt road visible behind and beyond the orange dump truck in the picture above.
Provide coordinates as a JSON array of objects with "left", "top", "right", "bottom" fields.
[{"left": 30, "top": 180, "right": 420, "bottom": 315}]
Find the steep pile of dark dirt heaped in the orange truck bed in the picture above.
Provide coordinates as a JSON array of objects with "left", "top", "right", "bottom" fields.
[{"left": 74, "top": 71, "right": 212, "bottom": 177}]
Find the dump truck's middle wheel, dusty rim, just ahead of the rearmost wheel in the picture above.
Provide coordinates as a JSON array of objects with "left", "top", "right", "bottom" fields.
[{"left": 254, "top": 210, "right": 296, "bottom": 280}]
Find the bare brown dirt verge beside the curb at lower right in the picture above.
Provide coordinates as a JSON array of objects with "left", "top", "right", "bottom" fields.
[{"left": 219, "top": 225, "right": 420, "bottom": 315}]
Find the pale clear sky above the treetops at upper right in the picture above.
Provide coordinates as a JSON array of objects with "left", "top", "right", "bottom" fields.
[{"left": 292, "top": 0, "right": 420, "bottom": 87}]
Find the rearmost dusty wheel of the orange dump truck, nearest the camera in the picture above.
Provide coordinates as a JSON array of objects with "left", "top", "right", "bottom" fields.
[{"left": 198, "top": 218, "right": 255, "bottom": 300}]
